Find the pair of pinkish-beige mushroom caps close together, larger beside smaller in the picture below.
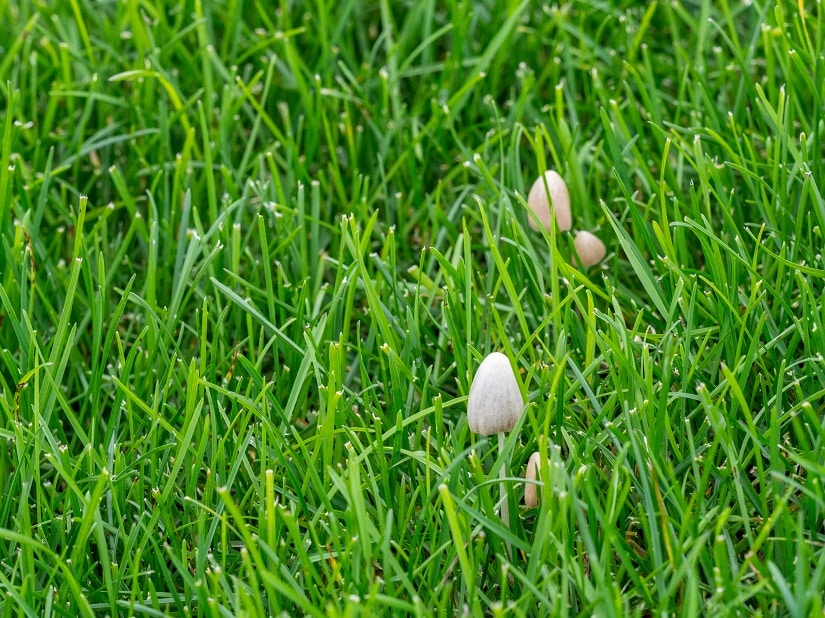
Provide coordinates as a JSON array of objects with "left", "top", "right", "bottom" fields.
[{"left": 527, "top": 170, "right": 606, "bottom": 268}]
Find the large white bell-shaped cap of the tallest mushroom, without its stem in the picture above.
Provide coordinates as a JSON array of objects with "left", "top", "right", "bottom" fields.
[{"left": 467, "top": 352, "right": 524, "bottom": 436}]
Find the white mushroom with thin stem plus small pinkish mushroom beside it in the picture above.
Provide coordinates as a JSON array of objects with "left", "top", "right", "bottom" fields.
[{"left": 467, "top": 352, "right": 552, "bottom": 527}]
